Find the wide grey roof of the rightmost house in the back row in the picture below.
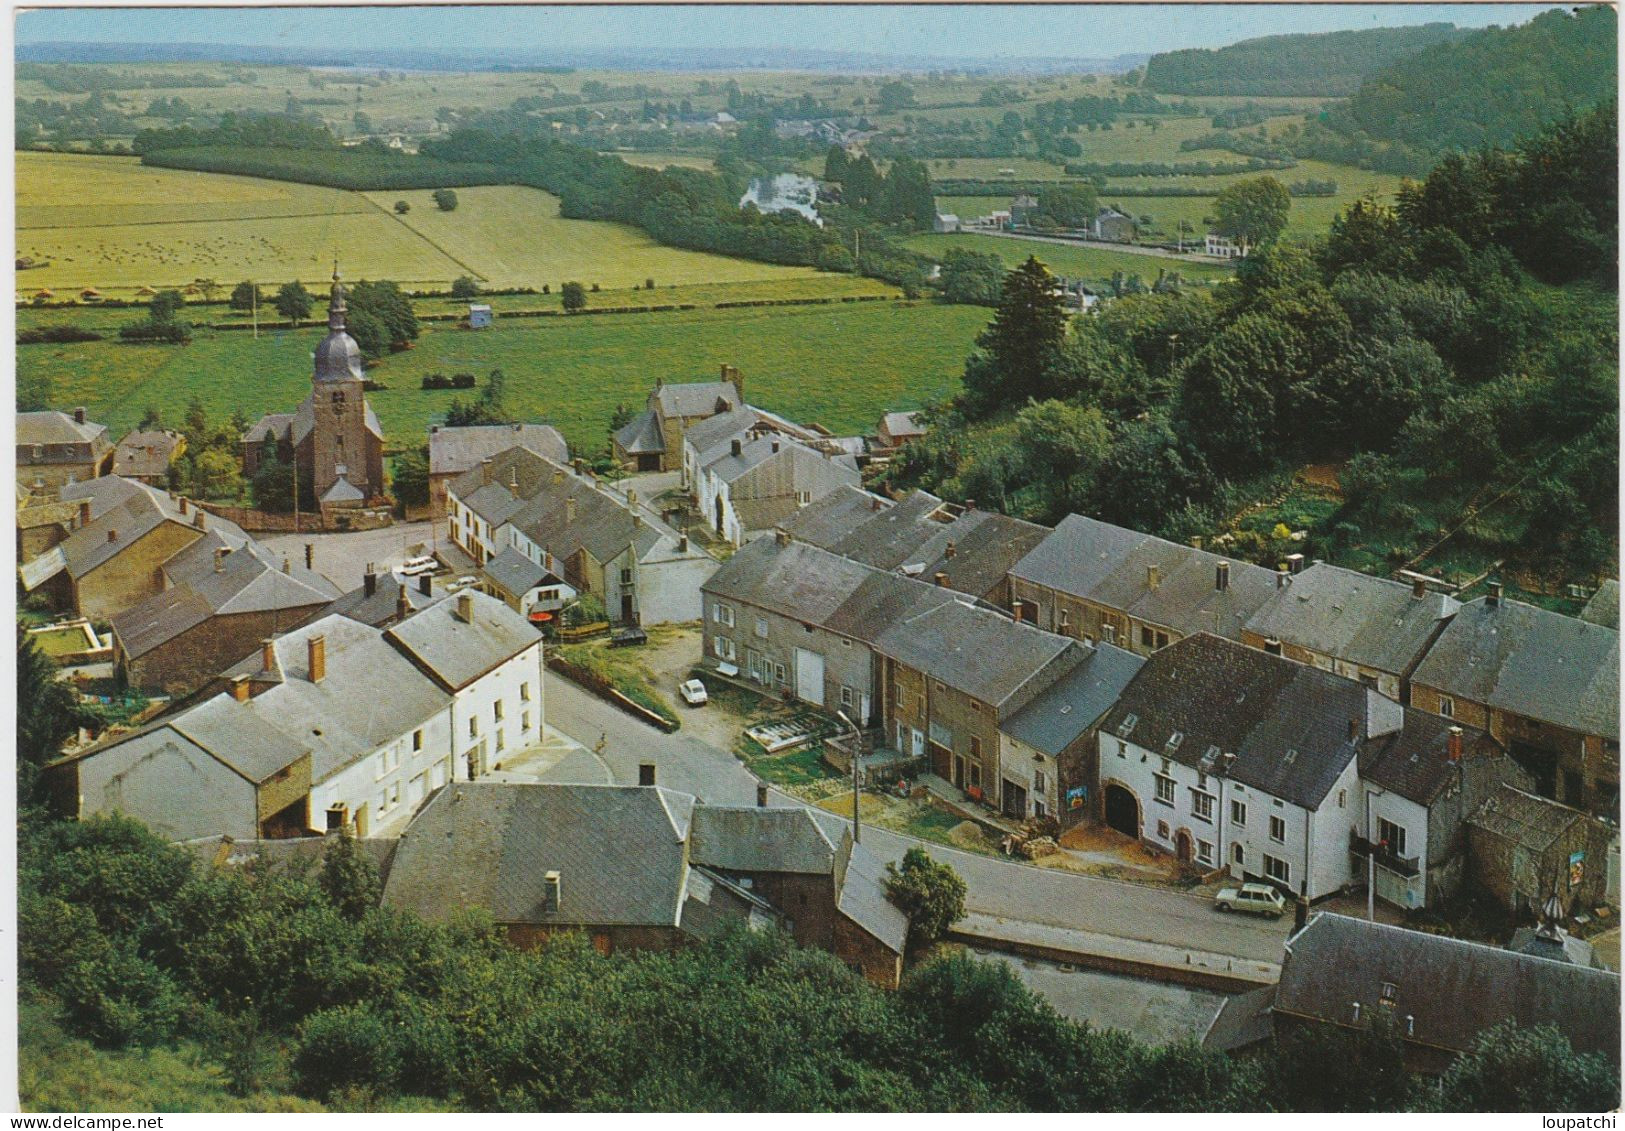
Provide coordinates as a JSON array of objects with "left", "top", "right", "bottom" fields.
[{"left": 1412, "top": 598, "right": 1620, "bottom": 741}]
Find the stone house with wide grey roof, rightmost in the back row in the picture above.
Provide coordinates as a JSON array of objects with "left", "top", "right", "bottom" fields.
[{"left": 1411, "top": 585, "right": 1620, "bottom": 817}]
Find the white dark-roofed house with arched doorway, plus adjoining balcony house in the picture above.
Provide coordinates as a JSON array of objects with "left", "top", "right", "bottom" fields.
[{"left": 1092, "top": 634, "right": 1523, "bottom": 908}]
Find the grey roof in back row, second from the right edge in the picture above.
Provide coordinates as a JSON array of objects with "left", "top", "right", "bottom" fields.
[{"left": 1232, "top": 562, "right": 1461, "bottom": 674}]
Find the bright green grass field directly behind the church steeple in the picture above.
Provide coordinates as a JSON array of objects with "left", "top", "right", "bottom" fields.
[{"left": 28, "top": 302, "right": 988, "bottom": 452}]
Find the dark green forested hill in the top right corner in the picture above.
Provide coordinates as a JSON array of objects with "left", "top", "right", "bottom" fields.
[{"left": 1328, "top": 8, "right": 1619, "bottom": 156}]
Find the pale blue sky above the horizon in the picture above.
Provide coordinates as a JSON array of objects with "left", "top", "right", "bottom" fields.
[{"left": 15, "top": 3, "right": 1554, "bottom": 59}]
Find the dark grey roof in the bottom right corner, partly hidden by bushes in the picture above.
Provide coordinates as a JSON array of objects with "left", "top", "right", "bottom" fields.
[{"left": 1274, "top": 913, "right": 1620, "bottom": 1060}]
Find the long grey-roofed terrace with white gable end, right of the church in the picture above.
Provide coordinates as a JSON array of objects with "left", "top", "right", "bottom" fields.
[{"left": 447, "top": 447, "right": 717, "bottom": 624}]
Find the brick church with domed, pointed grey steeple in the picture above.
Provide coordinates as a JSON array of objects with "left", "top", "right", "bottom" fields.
[{"left": 242, "top": 267, "right": 384, "bottom": 514}]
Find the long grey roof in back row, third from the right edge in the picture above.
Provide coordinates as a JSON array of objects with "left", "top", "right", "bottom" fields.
[{"left": 1011, "top": 515, "right": 1276, "bottom": 640}]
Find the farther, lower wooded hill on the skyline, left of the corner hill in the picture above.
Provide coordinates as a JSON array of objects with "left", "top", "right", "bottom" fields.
[{"left": 1142, "top": 23, "right": 1471, "bottom": 98}]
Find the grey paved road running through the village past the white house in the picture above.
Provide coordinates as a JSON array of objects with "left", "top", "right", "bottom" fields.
[{"left": 546, "top": 673, "right": 1292, "bottom": 962}]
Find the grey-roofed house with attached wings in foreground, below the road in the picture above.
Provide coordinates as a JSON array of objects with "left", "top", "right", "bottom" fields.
[{"left": 384, "top": 782, "right": 908, "bottom": 986}]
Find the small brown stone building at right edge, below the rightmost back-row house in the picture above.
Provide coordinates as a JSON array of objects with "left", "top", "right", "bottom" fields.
[{"left": 1467, "top": 785, "right": 1619, "bottom": 918}]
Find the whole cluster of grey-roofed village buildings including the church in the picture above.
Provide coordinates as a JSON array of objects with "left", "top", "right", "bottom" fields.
[{"left": 16, "top": 260, "right": 1620, "bottom": 1053}]
